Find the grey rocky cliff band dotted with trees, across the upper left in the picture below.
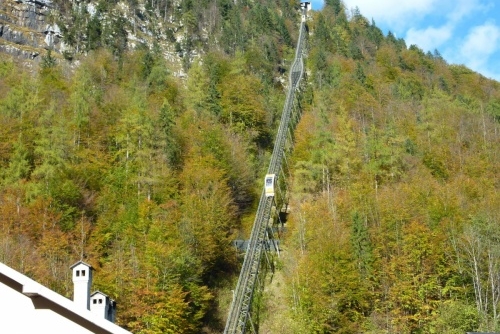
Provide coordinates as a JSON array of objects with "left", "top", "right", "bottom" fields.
[{"left": 0, "top": 0, "right": 193, "bottom": 76}]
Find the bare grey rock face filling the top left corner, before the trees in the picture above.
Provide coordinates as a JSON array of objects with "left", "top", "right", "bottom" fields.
[{"left": 0, "top": 0, "right": 64, "bottom": 60}]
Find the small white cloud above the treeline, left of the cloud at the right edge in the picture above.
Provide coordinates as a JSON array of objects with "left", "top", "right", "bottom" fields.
[{"left": 405, "top": 24, "right": 453, "bottom": 51}]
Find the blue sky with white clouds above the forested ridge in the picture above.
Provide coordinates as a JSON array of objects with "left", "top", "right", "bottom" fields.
[{"left": 311, "top": 0, "right": 500, "bottom": 81}]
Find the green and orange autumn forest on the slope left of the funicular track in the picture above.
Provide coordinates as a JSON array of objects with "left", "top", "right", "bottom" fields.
[{"left": 0, "top": 0, "right": 299, "bottom": 333}]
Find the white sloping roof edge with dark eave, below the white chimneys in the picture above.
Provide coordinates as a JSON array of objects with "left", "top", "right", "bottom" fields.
[{"left": 0, "top": 262, "right": 131, "bottom": 334}]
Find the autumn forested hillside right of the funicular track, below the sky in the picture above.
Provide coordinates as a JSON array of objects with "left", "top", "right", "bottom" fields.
[{"left": 275, "top": 1, "right": 500, "bottom": 334}]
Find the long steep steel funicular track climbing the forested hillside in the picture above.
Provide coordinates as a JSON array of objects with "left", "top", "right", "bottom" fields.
[{"left": 224, "top": 9, "right": 306, "bottom": 334}]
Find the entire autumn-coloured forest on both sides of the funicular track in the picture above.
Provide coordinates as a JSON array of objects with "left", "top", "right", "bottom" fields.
[{"left": 0, "top": 0, "right": 500, "bottom": 334}]
